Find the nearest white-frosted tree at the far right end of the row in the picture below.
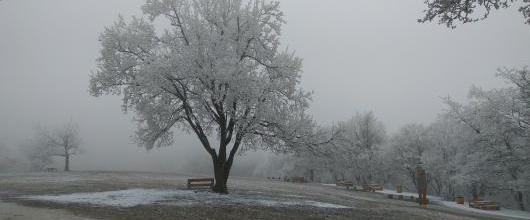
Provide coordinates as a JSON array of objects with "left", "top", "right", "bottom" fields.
[{"left": 447, "top": 68, "right": 530, "bottom": 210}]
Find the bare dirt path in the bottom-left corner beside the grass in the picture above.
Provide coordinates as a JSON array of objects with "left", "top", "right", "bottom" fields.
[{"left": 0, "top": 202, "right": 91, "bottom": 220}]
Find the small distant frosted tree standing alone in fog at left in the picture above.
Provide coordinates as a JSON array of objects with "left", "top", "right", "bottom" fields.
[{"left": 33, "top": 122, "right": 81, "bottom": 171}]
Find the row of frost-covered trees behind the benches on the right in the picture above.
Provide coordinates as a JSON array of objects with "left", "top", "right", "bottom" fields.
[{"left": 268, "top": 68, "right": 530, "bottom": 210}]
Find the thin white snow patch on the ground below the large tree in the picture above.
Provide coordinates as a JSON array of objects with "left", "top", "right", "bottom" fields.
[{"left": 20, "top": 189, "right": 350, "bottom": 209}]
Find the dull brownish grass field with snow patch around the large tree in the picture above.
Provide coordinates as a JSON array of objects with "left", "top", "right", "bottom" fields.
[{"left": 0, "top": 172, "right": 512, "bottom": 220}]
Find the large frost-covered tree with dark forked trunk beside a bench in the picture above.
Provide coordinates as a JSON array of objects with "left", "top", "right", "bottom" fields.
[{"left": 90, "top": 0, "right": 314, "bottom": 193}]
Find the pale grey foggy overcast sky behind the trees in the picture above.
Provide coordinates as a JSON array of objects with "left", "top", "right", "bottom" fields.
[{"left": 0, "top": 0, "right": 530, "bottom": 170}]
